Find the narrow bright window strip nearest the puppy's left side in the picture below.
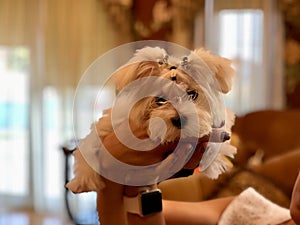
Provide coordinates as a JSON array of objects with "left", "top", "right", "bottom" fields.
[{"left": 43, "top": 87, "right": 65, "bottom": 199}]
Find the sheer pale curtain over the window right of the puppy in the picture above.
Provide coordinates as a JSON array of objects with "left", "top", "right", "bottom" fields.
[{"left": 204, "top": 0, "right": 285, "bottom": 114}]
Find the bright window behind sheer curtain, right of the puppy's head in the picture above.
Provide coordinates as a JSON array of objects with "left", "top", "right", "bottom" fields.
[{"left": 219, "top": 9, "right": 267, "bottom": 113}]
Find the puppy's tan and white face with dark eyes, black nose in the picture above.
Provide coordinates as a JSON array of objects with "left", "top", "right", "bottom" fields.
[{"left": 130, "top": 62, "right": 211, "bottom": 143}]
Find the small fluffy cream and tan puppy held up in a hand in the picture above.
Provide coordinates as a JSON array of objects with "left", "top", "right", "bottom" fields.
[{"left": 67, "top": 47, "right": 235, "bottom": 193}]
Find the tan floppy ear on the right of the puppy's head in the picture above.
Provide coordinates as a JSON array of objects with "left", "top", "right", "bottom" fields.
[{"left": 194, "top": 48, "right": 235, "bottom": 93}]
